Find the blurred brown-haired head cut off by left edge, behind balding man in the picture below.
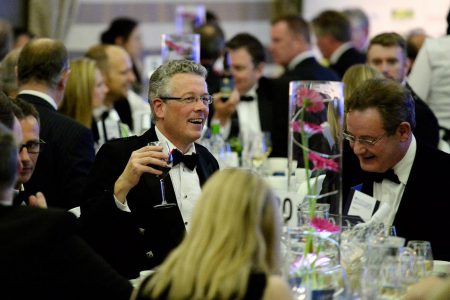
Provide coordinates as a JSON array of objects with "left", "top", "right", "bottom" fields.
[{"left": 0, "top": 49, "right": 21, "bottom": 98}]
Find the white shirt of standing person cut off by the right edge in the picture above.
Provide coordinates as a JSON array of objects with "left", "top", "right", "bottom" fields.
[{"left": 408, "top": 36, "right": 450, "bottom": 129}]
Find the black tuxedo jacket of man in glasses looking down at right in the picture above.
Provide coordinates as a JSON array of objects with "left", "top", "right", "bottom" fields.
[{"left": 348, "top": 141, "right": 450, "bottom": 261}]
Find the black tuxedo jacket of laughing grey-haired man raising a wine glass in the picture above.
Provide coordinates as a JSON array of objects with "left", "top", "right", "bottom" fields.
[{"left": 81, "top": 127, "right": 219, "bottom": 278}]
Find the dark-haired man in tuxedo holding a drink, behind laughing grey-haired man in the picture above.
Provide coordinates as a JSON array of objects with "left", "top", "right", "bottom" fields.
[{"left": 212, "top": 33, "right": 278, "bottom": 153}]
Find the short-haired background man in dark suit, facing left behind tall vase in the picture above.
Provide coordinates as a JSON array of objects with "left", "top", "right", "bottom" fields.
[{"left": 269, "top": 15, "right": 340, "bottom": 158}]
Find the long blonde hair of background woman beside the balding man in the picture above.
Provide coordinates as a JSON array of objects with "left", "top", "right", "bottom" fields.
[{"left": 58, "top": 58, "right": 97, "bottom": 128}]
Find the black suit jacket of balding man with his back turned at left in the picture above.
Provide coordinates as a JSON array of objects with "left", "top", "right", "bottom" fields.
[{"left": 18, "top": 94, "right": 95, "bottom": 209}]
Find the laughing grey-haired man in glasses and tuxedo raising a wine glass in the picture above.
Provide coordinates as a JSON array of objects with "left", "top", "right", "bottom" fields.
[{"left": 81, "top": 60, "right": 219, "bottom": 278}]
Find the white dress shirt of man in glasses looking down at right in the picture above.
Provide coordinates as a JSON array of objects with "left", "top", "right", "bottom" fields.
[{"left": 373, "top": 135, "right": 417, "bottom": 226}]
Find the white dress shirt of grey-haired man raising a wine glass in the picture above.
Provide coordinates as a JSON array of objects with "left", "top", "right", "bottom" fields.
[{"left": 114, "top": 126, "right": 201, "bottom": 230}]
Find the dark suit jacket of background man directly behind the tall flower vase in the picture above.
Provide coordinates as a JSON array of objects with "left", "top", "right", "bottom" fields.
[{"left": 272, "top": 57, "right": 340, "bottom": 159}]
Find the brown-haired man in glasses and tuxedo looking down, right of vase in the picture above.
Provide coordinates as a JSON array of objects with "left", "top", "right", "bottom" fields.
[{"left": 343, "top": 78, "right": 450, "bottom": 260}]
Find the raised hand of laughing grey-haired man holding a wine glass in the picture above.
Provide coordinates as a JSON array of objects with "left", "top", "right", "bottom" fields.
[{"left": 114, "top": 146, "right": 168, "bottom": 203}]
